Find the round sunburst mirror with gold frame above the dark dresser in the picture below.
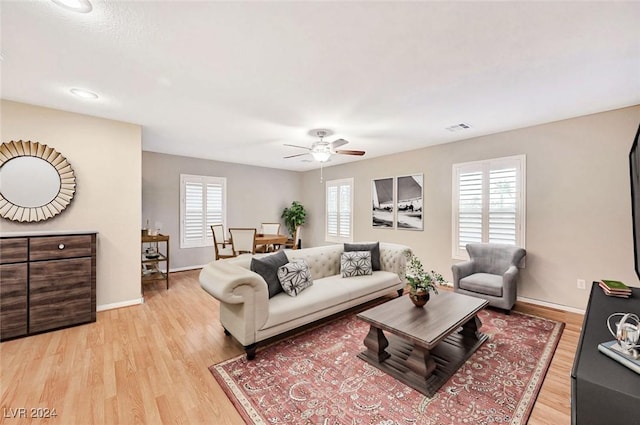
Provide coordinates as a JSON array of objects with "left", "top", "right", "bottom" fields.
[{"left": 0, "top": 140, "right": 76, "bottom": 222}]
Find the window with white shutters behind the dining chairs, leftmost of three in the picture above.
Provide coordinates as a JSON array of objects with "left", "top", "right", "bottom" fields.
[{"left": 180, "top": 174, "right": 227, "bottom": 248}]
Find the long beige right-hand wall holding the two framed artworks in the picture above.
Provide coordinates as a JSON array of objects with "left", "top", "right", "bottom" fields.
[{"left": 303, "top": 106, "right": 640, "bottom": 309}]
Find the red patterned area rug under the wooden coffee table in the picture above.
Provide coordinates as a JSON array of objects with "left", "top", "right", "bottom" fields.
[{"left": 209, "top": 310, "right": 564, "bottom": 425}]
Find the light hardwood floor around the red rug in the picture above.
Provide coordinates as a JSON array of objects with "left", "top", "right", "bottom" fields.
[{"left": 0, "top": 270, "right": 582, "bottom": 425}]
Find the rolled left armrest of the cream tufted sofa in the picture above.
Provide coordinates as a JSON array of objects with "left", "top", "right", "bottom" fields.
[{"left": 200, "top": 260, "right": 269, "bottom": 334}]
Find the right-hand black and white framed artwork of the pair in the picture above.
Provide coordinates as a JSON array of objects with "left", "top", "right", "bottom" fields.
[{"left": 396, "top": 174, "right": 424, "bottom": 230}]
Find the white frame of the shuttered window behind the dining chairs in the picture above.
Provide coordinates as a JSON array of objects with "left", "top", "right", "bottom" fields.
[{"left": 180, "top": 174, "right": 227, "bottom": 248}]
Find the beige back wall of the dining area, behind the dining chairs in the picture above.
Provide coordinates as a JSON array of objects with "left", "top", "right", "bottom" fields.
[{"left": 142, "top": 152, "right": 302, "bottom": 270}]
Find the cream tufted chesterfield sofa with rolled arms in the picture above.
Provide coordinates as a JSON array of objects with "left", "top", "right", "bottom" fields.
[{"left": 200, "top": 243, "right": 409, "bottom": 359}]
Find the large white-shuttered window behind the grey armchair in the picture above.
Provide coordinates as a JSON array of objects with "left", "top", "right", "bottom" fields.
[{"left": 452, "top": 155, "right": 526, "bottom": 259}]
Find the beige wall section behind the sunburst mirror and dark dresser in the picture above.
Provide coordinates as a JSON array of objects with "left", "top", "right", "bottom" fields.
[{"left": 0, "top": 100, "right": 142, "bottom": 309}]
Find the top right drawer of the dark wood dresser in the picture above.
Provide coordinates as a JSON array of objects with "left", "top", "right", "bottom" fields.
[{"left": 29, "top": 235, "right": 94, "bottom": 261}]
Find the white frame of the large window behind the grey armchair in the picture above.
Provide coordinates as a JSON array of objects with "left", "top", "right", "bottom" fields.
[{"left": 451, "top": 154, "right": 527, "bottom": 260}]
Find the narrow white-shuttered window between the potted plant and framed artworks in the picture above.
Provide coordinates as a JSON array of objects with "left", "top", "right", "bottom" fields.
[{"left": 326, "top": 179, "right": 353, "bottom": 242}]
